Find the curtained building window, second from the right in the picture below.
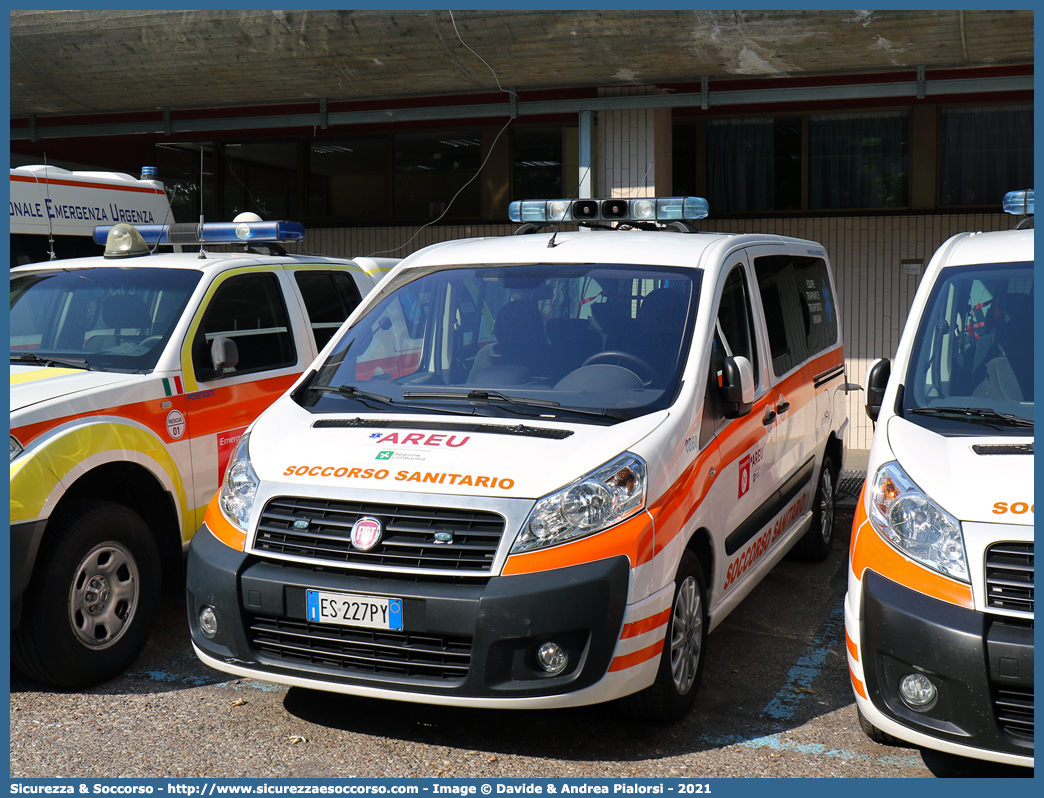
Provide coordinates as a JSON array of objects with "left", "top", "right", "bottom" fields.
[{"left": 808, "top": 111, "right": 909, "bottom": 210}]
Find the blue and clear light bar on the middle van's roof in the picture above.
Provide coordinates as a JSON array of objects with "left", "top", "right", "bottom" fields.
[{"left": 507, "top": 196, "right": 710, "bottom": 225}]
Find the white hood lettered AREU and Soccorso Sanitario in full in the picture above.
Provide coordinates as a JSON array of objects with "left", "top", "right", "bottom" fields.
[{"left": 250, "top": 397, "right": 668, "bottom": 498}]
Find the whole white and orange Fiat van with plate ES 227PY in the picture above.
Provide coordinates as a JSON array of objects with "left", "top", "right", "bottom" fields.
[{"left": 187, "top": 197, "right": 847, "bottom": 720}]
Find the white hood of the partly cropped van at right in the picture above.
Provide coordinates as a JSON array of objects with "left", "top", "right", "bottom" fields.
[{"left": 887, "top": 416, "right": 1034, "bottom": 526}]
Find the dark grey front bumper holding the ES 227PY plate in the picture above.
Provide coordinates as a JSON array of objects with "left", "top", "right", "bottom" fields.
[{"left": 187, "top": 525, "right": 630, "bottom": 703}]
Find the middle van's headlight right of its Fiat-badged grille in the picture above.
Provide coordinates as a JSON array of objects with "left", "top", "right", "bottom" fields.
[{"left": 512, "top": 454, "right": 646, "bottom": 553}]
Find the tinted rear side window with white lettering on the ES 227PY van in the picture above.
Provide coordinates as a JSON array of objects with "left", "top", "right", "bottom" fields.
[{"left": 754, "top": 255, "right": 837, "bottom": 377}]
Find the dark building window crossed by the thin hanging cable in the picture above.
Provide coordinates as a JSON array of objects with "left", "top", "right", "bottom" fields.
[{"left": 393, "top": 130, "right": 482, "bottom": 221}]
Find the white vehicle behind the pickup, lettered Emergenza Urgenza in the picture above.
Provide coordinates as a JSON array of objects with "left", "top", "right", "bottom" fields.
[{"left": 10, "top": 165, "right": 175, "bottom": 266}]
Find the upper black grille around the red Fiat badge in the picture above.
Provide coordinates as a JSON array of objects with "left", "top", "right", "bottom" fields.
[{"left": 254, "top": 496, "right": 504, "bottom": 573}]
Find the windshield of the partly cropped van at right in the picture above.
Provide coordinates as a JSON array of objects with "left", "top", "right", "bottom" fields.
[{"left": 903, "top": 263, "right": 1034, "bottom": 436}]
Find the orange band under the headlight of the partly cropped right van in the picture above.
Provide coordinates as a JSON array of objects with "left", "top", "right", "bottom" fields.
[{"left": 850, "top": 487, "right": 975, "bottom": 609}]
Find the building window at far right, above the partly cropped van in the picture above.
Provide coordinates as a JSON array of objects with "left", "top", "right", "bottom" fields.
[{"left": 939, "top": 105, "right": 1034, "bottom": 206}]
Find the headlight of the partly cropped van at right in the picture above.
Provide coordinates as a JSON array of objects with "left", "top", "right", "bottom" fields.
[{"left": 870, "top": 462, "right": 969, "bottom": 582}]
